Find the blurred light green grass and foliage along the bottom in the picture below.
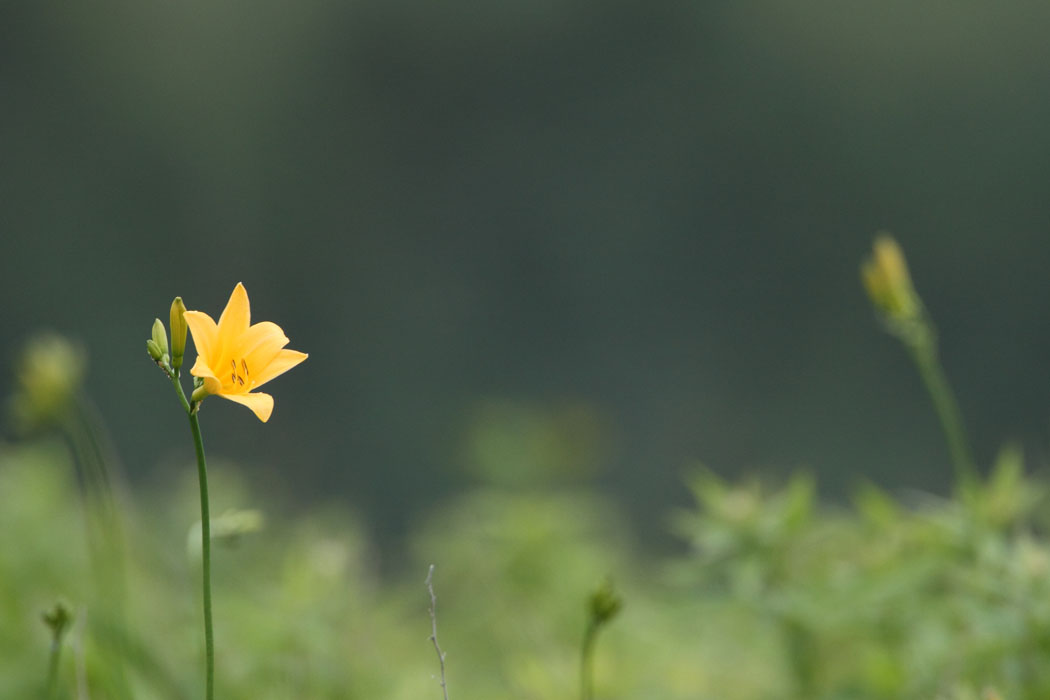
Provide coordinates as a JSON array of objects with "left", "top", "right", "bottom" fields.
[{"left": 0, "top": 432, "right": 1050, "bottom": 700}]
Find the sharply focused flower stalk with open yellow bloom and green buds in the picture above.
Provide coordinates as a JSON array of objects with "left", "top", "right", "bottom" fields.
[{"left": 146, "top": 282, "right": 307, "bottom": 700}]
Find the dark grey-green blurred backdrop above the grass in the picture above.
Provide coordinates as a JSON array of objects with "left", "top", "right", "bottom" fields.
[{"left": 0, "top": 0, "right": 1050, "bottom": 558}]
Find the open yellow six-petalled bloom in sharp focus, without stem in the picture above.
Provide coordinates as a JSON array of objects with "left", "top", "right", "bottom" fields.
[{"left": 183, "top": 282, "right": 307, "bottom": 423}]
